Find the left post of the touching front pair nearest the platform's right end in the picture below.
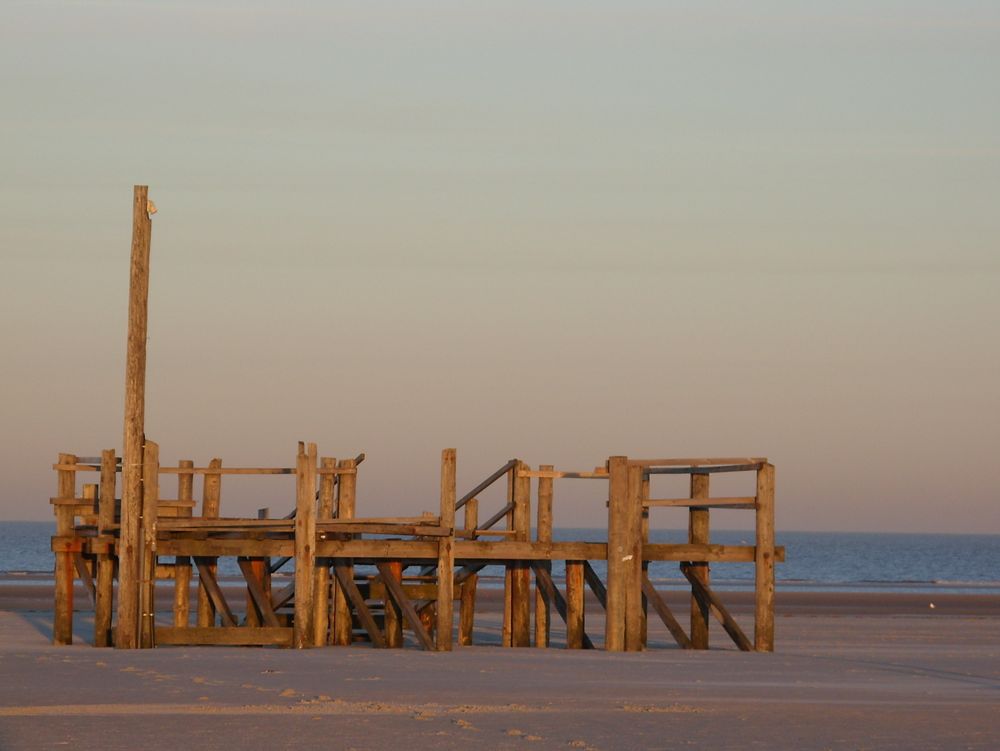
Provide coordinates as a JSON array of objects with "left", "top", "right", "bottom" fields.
[{"left": 604, "top": 456, "right": 632, "bottom": 652}]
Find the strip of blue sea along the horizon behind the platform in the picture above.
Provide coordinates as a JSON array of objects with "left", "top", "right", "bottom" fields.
[{"left": 0, "top": 522, "right": 1000, "bottom": 595}]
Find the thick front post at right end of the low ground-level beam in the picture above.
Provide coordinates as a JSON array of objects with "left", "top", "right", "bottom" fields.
[{"left": 292, "top": 443, "right": 316, "bottom": 649}]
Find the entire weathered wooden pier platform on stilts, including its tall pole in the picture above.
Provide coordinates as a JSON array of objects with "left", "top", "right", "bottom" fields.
[{"left": 51, "top": 186, "right": 784, "bottom": 652}]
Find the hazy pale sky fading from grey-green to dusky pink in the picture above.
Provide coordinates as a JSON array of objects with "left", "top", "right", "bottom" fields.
[{"left": 0, "top": 0, "right": 1000, "bottom": 534}]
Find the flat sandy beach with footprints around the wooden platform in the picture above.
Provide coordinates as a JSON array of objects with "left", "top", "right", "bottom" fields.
[{"left": 0, "top": 584, "right": 1000, "bottom": 751}]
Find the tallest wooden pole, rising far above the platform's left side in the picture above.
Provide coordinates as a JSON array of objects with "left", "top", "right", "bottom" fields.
[{"left": 115, "top": 185, "right": 152, "bottom": 649}]
